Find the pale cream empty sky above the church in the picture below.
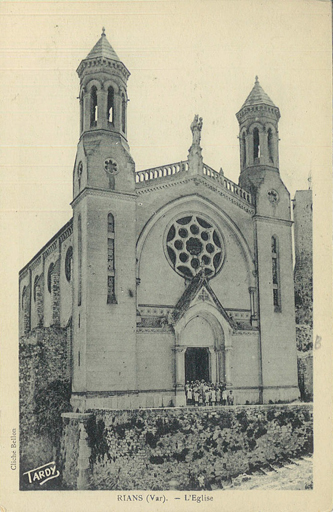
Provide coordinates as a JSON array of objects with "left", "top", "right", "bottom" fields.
[{"left": 0, "top": 0, "right": 331, "bottom": 276}]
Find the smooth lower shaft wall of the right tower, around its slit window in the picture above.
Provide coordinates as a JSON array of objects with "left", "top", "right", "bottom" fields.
[{"left": 254, "top": 222, "right": 298, "bottom": 400}]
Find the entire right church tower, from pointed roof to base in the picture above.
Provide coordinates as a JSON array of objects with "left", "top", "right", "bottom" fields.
[{"left": 236, "top": 77, "right": 299, "bottom": 403}]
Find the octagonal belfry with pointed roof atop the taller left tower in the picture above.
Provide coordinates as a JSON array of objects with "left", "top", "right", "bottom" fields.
[{"left": 73, "top": 28, "right": 135, "bottom": 198}]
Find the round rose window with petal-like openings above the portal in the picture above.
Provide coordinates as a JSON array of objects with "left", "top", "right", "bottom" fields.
[{"left": 166, "top": 215, "right": 223, "bottom": 278}]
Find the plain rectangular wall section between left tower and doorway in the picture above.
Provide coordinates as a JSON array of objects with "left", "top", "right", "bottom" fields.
[{"left": 137, "top": 329, "right": 175, "bottom": 390}]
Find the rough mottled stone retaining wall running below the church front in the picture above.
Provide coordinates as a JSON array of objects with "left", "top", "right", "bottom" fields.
[{"left": 59, "top": 404, "right": 313, "bottom": 490}]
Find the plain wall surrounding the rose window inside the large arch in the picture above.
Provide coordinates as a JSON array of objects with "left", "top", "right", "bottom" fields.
[{"left": 138, "top": 197, "right": 253, "bottom": 309}]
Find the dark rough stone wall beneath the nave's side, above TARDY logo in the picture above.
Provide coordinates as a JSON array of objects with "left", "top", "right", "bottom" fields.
[{"left": 19, "top": 327, "right": 70, "bottom": 490}]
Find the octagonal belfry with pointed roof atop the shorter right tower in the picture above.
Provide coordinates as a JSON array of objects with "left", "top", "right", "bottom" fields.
[{"left": 236, "top": 76, "right": 280, "bottom": 192}]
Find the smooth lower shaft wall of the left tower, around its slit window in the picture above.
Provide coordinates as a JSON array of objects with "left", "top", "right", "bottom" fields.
[{"left": 76, "top": 194, "right": 136, "bottom": 391}]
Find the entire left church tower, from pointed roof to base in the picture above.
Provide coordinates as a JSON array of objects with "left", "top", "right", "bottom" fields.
[{"left": 72, "top": 28, "right": 136, "bottom": 411}]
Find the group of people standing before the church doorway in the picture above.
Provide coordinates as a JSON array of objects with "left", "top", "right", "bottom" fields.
[{"left": 185, "top": 380, "right": 234, "bottom": 406}]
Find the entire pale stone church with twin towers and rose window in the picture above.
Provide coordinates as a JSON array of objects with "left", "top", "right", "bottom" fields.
[{"left": 20, "top": 31, "right": 299, "bottom": 412}]
